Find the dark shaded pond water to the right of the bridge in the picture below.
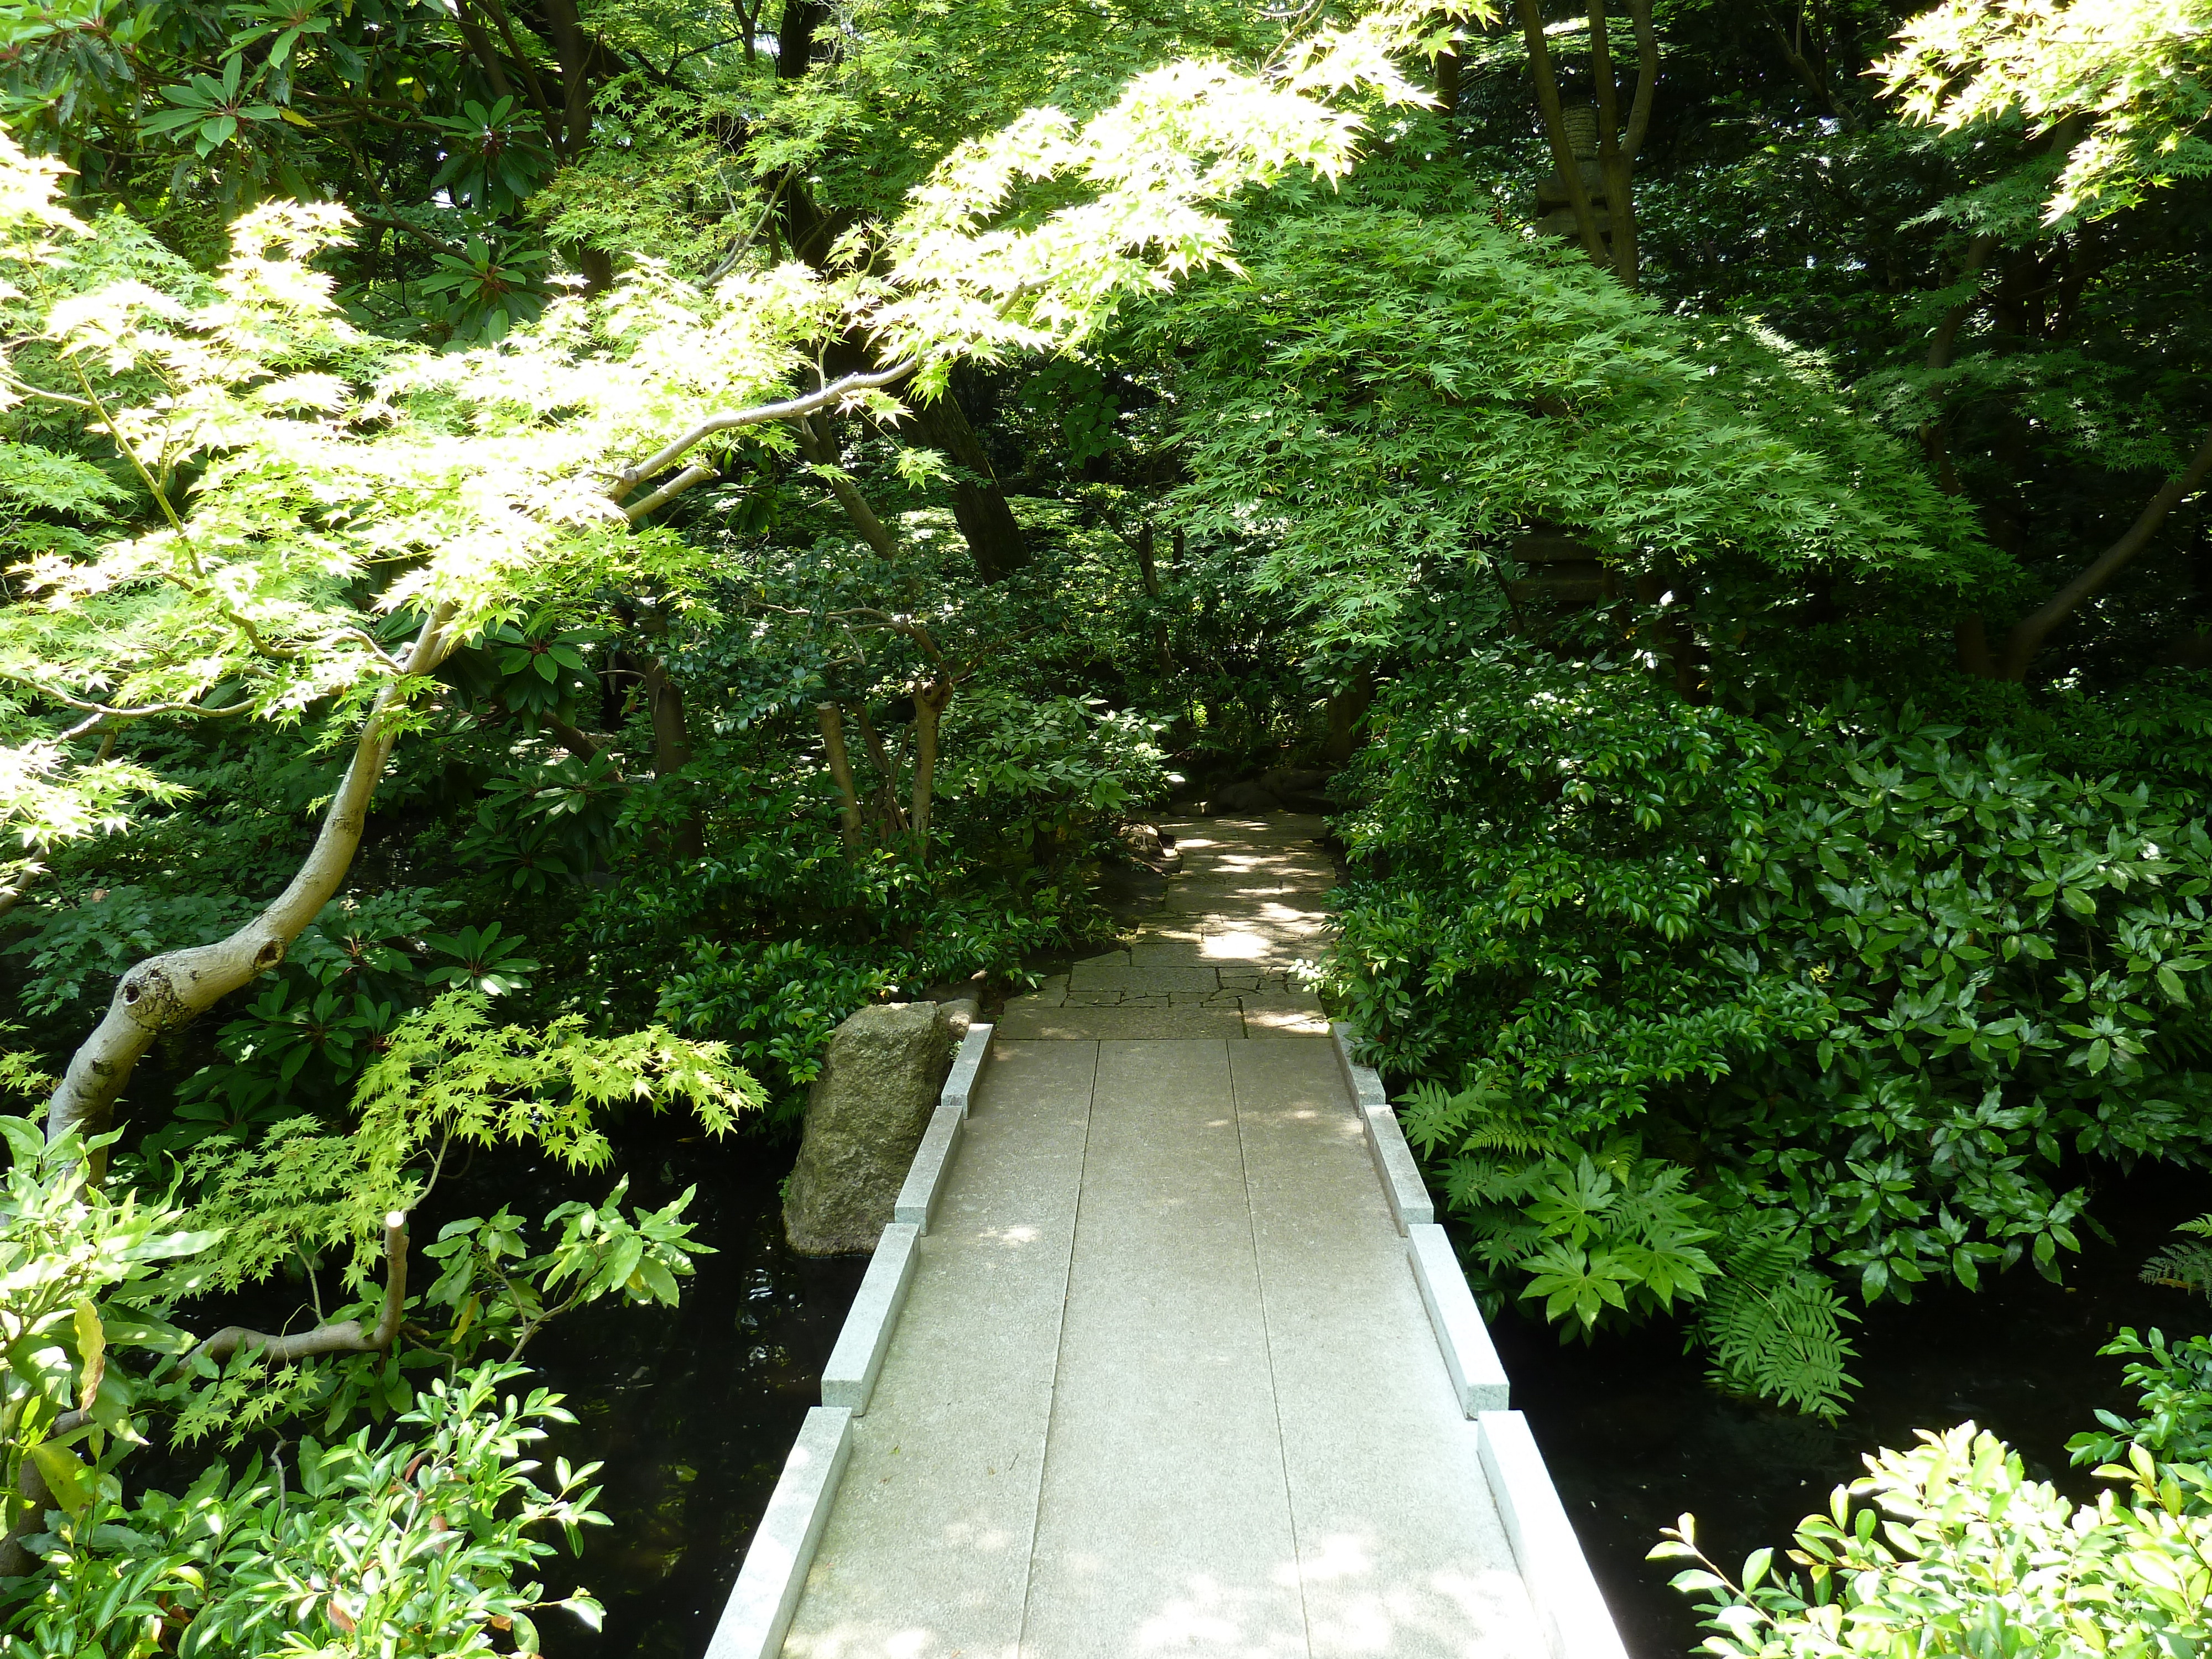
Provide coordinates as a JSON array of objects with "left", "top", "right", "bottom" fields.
[{"left": 1493, "top": 1170, "right": 2212, "bottom": 1659}]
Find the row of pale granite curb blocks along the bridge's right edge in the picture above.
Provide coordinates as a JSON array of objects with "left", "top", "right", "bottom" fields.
[{"left": 1329, "top": 1020, "right": 1628, "bottom": 1659}]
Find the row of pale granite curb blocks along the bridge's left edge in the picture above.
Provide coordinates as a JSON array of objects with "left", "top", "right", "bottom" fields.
[{"left": 706, "top": 1024, "right": 991, "bottom": 1659}]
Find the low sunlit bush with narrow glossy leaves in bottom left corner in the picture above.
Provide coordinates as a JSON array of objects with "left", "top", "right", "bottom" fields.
[{"left": 0, "top": 1365, "right": 606, "bottom": 1659}]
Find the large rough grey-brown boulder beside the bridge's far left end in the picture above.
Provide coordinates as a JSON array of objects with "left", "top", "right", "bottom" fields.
[{"left": 783, "top": 1002, "right": 958, "bottom": 1256}]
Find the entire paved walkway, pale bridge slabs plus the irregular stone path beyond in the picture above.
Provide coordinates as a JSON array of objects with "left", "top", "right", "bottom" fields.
[{"left": 783, "top": 818, "right": 1544, "bottom": 1659}]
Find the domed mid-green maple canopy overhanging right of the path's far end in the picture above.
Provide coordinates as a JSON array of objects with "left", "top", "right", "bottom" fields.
[{"left": 1150, "top": 204, "right": 1997, "bottom": 646}]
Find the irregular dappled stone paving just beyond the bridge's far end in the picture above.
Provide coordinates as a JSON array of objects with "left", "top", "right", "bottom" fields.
[{"left": 998, "top": 814, "right": 1336, "bottom": 1037}]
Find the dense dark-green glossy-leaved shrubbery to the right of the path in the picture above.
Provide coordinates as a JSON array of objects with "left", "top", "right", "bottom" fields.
[{"left": 1327, "top": 650, "right": 2212, "bottom": 1398}]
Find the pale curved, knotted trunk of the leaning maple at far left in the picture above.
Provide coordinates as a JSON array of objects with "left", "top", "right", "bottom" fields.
[{"left": 46, "top": 606, "right": 458, "bottom": 1179}]
